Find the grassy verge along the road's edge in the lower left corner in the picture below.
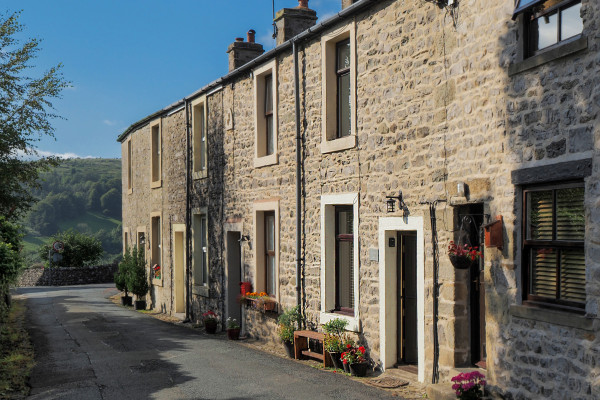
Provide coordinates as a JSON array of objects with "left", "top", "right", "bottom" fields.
[{"left": 0, "top": 300, "right": 35, "bottom": 399}]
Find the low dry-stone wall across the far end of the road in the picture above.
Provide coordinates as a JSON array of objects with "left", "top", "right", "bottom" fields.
[{"left": 15, "top": 264, "right": 118, "bottom": 287}]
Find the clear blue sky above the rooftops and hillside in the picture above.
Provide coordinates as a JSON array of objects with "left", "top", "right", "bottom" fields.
[{"left": 0, "top": 0, "right": 341, "bottom": 158}]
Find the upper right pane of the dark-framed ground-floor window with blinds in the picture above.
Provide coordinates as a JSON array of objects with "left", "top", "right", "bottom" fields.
[{"left": 556, "top": 187, "right": 585, "bottom": 240}]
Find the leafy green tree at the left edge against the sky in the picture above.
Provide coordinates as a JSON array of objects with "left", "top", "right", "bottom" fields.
[{"left": 0, "top": 12, "right": 69, "bottom": 220}]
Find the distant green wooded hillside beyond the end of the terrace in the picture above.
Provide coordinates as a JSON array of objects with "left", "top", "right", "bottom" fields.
[{"left": 22, "top": 159, "right": 121, "bottom": 264}]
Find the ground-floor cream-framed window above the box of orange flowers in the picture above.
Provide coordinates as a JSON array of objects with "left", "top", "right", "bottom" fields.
[{"left": 254, "top": 200, "right": 279, "bottom": 298}]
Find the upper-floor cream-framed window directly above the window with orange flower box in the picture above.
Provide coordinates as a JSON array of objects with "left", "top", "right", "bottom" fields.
[{"left": 254, "top": 60, "right": 278, "bottom": 167}]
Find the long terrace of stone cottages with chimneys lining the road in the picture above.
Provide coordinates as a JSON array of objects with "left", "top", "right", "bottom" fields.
[{"left": 119, "top": 0, "right": 600, "bottom": 399}]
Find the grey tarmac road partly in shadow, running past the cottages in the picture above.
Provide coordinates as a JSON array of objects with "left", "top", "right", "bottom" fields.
[{"left": 17, "top": 285, "right": 398, "bottom": 400}]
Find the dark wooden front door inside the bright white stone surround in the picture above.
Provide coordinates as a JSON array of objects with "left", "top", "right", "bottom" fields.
[{"left": 396, "top": 232, "right": 418, "bottom": 364}]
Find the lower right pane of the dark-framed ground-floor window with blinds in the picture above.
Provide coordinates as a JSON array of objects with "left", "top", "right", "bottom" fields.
[{"left": 560, "top": 249, "right": 585, "bottom": 303}]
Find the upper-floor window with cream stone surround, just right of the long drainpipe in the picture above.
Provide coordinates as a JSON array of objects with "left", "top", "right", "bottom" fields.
[{"left": 321, "top": 23, "right": 356, "bottom": 153}]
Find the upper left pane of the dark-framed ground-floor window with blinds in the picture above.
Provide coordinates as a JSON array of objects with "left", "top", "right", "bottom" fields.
[{"left": 527, "top": 190, "right": 552, "bottom": 240}]
